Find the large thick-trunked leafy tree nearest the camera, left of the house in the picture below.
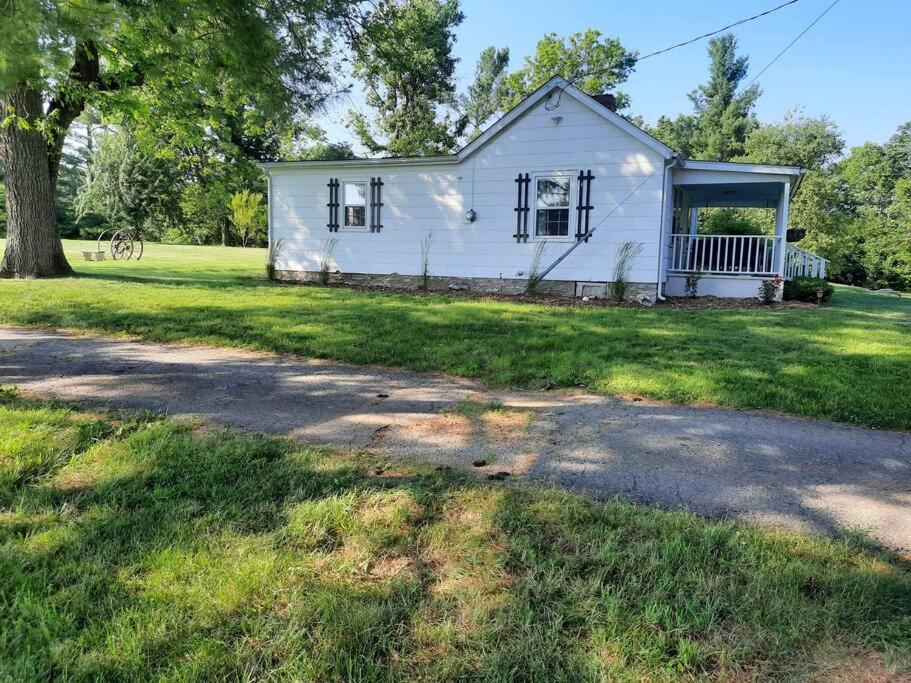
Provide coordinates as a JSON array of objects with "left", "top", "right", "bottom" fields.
[{"left": 0, "top": 0, "right": 353, "bottom": 278}]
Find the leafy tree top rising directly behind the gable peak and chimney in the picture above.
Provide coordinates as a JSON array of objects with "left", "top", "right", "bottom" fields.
[{"left": 501, "top": 28, "right": 637, "bottom": 111}]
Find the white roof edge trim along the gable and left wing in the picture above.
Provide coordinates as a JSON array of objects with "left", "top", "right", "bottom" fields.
[{"left": 259, "top": 76, "right": 676, "bottom": 170}]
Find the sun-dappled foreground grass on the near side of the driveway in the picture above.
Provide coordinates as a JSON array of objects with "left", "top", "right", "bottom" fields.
[{"left": 0, "top": 392, "right": 911, "bottom": 681}]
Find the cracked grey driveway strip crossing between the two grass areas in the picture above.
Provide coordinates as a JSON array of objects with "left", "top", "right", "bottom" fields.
[{"left": 0, "top": 327, "right": 911, "bottom": 550}]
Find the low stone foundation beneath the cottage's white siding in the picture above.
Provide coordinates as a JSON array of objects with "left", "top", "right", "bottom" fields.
[{"left": 275, "top": 270, "right": 657, "bottom": 301}]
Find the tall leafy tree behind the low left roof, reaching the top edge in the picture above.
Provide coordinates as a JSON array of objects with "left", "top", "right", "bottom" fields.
[{"left": 349, "top": 0, "right": 464, "bottom": 156}]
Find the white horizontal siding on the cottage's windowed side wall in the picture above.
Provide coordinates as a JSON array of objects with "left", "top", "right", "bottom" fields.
[{"left": 270, "top": 97, "right": 664, "bottom": 282}]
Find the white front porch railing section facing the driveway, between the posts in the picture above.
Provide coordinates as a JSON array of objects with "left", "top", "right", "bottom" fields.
[{"left": 670, "top": 235, "right": 780, "bottom": 275}]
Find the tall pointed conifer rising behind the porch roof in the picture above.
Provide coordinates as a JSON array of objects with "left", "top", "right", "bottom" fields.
[{"left": 651, "top": 33, "right": 760, "bottom": 161}]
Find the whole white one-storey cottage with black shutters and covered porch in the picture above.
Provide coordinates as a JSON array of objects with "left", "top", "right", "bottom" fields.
[{"left": 263, "top": 78, "right": 825, "bottom": 298}]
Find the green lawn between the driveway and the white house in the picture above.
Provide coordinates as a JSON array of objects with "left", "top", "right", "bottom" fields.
[{"left": 0, "top": 242, "right": 911, "bottom": 430}]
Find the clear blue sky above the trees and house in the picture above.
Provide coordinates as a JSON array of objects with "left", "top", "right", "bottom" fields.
[{"left": 321, "top": 0, "right": 911, "bottom": 151}]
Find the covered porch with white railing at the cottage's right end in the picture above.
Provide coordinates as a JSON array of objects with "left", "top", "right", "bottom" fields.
[{"left": 665, "top": 161, "right": 827, "bottom": 296}]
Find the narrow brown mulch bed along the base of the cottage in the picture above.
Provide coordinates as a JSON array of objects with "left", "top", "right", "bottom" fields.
[{"left": 279, "top": 282, "right": 816, "bottom": 311}]
